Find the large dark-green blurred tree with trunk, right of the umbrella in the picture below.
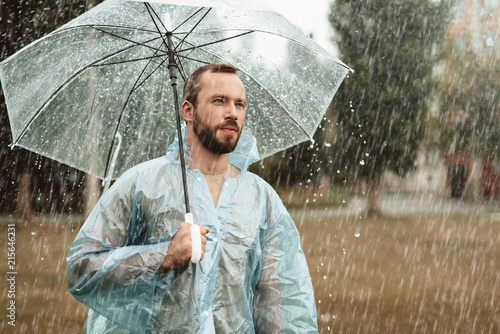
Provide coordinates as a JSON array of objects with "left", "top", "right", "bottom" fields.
[{"left": 329, "top": 0, "right": 448, "bottom": 213}]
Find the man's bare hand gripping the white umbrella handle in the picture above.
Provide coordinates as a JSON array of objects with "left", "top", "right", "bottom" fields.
[{"left": 162, "top": 223, "right": 210, "bottom": 272}]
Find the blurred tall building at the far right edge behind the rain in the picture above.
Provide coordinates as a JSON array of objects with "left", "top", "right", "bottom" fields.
[{"left": 444, "top": 0, "right": 500, "bottom": 199}]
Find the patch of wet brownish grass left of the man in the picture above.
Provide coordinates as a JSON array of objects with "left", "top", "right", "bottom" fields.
[{"left": 0, "top": 223, "right": 87, "bottom": 334}]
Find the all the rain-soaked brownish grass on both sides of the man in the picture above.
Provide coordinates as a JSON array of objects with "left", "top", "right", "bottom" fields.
[{"left": 0, "top": 214, "right": 500, "bottom": 333}]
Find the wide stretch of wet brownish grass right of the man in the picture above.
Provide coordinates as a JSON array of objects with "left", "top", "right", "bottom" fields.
[{"left": 296, "top": 214, "right": 500, "bottom": 333}]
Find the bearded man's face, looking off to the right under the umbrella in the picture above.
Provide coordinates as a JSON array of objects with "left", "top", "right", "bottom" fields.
[{"left": 193, "top": 72, "right": 246, "bottom": 154}]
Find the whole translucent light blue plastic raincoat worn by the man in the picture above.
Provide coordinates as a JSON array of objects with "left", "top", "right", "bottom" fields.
[{"left": 67, "top": 128, "right": 317, "bottom": 334}]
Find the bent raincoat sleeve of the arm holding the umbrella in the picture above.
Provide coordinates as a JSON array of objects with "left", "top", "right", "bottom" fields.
[{"left": 67, "top": 173, "right": 174, "bottom": 333}]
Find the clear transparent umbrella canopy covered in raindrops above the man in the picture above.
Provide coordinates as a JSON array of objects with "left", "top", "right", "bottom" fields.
[{"left": 0, "top": 0, "right": 349, "bottom": 183}]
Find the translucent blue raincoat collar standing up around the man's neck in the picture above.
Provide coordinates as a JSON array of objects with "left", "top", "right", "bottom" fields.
[{"left": 167, "top": 123, "right": 260, "bottom": 172}]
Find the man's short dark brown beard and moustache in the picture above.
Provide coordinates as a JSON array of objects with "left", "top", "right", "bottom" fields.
[{"left": 193, "top": 110, "right": 241, "bottom": 154}]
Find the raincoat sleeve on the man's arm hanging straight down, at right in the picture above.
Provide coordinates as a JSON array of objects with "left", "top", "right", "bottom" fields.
[{"left": 254, "top": 195, "right": 318, "bottom": 333}]
